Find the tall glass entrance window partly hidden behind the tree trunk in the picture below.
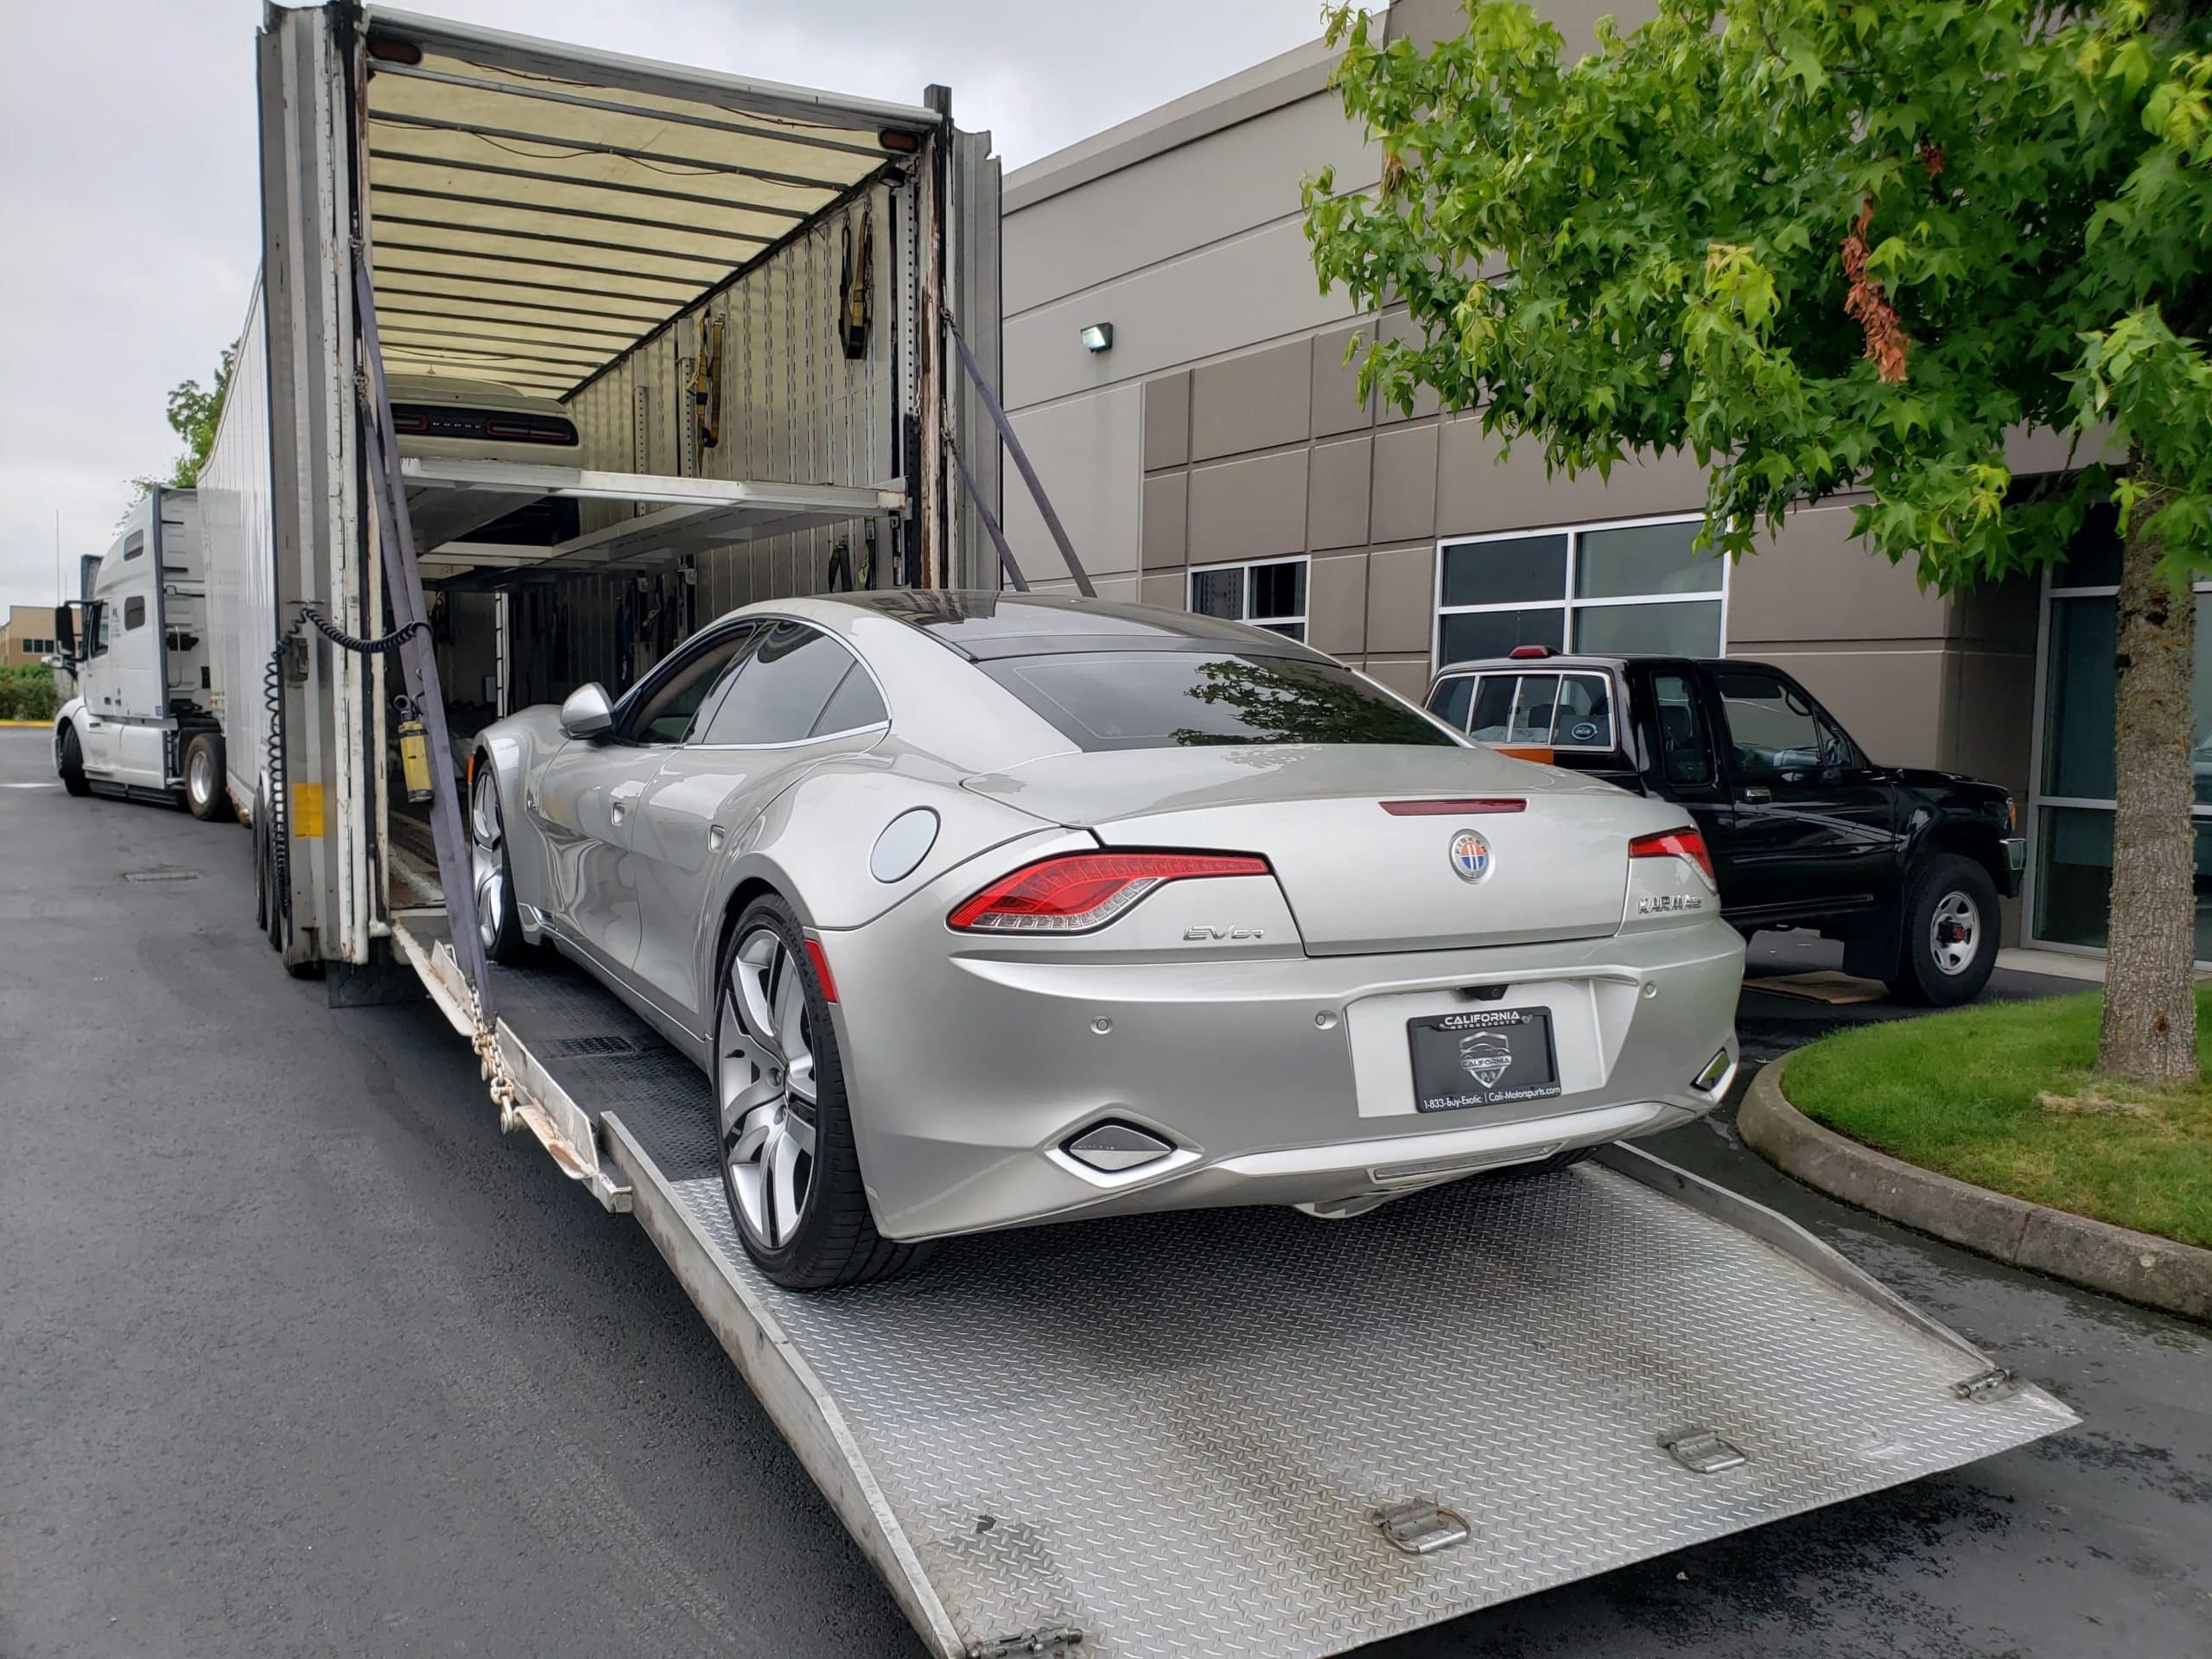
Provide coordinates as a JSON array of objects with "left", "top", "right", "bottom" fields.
[{"left": 2029, "top": 511, "right": 2212, "bottom": 963}]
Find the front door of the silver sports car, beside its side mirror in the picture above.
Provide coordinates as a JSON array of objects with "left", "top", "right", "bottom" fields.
[{"left": 524, "top": 624, "right": 752, "bottom": 984}]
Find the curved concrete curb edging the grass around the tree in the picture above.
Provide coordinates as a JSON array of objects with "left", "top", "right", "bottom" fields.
[{"left": 1737, "top": 1062, "right": 2212, "bottom": 1320}]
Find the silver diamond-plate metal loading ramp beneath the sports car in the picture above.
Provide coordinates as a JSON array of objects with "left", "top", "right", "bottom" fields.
[{"left": 394, "top": 912, "right": 2075, "bottom": 1659}]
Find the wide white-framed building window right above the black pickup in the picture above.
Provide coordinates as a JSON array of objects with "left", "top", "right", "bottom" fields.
[{"left": 1435, "top": 515, "right": 1727, "bottom": 668}]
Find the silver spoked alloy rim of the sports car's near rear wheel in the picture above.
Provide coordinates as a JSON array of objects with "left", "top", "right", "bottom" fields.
[{"left": 715, "top": 927, "right": 817, "bottom": 1249}]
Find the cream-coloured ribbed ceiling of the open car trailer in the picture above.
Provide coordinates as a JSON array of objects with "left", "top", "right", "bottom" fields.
[{"left": 365, "top": 11, "right": 938, "bottom": 396}]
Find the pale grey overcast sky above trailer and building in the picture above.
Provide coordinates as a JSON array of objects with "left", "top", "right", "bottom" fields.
[{"left": 0, "top": 0, "right": 1320, "bottom": 606}]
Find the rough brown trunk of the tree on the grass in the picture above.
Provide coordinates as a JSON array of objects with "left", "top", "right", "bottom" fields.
[{"left": 2097, "top": 502, "right": 2196, "bottom": 1084}]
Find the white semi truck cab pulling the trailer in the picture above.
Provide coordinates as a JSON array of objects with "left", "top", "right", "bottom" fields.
[{"left": 53, "top": 489, "right": 230, "bottom": 818}]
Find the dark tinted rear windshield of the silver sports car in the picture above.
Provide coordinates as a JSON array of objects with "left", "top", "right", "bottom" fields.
[{"left": 978, "top": 651, "right": 1453, "bottom": 750}]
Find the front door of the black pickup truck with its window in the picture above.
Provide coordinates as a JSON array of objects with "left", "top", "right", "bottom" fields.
[{"left": 1710, "top": 664, "right": 1897, "bottom": 923}]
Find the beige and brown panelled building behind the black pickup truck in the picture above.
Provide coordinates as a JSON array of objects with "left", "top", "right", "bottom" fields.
[{"left": 1004, "top": 0, "right": 2167, "bottom": 956}]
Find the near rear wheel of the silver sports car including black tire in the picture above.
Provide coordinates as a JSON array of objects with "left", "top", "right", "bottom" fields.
[{"left": 710, "top": 896, "right": 929, "bottom": 1289}]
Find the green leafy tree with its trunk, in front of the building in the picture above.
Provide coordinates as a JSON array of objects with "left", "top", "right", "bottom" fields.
[{"left": 1305, "top": 0, "right": 2212, "bottom": 1079}]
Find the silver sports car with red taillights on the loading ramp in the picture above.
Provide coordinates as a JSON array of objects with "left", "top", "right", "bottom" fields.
[{"left": 469, "top": 593, "right": 1743, "bottom": 1287}]
